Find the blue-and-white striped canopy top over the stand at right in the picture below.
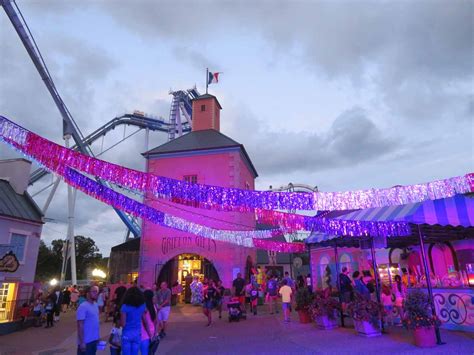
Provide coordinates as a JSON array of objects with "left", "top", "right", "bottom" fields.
[{"left": 335, "top": 195, "right": 474, "bottom": 227}]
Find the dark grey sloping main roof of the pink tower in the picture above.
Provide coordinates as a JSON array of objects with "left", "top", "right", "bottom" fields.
[{"left": 142, "top": 129, "right": 258, "bottom": 177}]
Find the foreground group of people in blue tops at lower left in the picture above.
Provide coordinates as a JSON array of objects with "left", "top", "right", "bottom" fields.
[{"left": 76, "top": 282, "right": 171, "bottom": 355}]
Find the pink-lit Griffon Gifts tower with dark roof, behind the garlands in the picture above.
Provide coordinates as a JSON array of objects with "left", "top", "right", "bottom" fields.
[{"left": 139, "top": 94, "right": 258, "bottom": 287}]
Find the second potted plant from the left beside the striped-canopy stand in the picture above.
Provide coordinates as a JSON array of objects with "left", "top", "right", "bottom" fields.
[{"left": 310, "top": 288, "right": 341, "bottom": 330}]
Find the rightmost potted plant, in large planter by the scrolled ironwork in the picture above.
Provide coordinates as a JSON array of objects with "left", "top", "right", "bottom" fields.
[{"left": 403, "top": 289, "right": 440, "bottom": 348}]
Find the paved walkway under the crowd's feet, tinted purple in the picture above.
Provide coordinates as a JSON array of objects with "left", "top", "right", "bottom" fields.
[{"left": 0, "top": 306, "right": 474, "bottom": 355}]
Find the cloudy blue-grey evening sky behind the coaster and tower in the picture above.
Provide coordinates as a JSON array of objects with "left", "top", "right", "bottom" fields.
[{"left": 0, "top": 0, "right": 474, "bottom": 255}]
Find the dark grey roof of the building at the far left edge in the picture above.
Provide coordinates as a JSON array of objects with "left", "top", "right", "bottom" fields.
[{"left": 0, "top": 179, "right": 43, "bottom": 223}]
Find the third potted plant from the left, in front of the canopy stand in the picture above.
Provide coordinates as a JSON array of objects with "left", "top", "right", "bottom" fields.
[{"left": 347, "top": 292, "right": 384, "bottom": 337}]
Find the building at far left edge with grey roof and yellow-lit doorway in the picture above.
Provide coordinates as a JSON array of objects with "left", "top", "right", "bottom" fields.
[{"left": 0, "top": 159, "right": 43, "bottom": 323}]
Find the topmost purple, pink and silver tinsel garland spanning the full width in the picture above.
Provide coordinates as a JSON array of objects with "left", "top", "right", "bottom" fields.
[{"left": 0, "top": 116, "right": 474, "bottom": 211}]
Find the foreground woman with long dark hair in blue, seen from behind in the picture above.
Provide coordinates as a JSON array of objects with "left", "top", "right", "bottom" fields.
[{"left": 120, "top": 286, "right": 149, "bottom": 355}]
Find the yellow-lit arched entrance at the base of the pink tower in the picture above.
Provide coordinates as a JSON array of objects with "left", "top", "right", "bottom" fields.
[{"left": 156, "top": 254, "right": 219, "bottom": 303}]
